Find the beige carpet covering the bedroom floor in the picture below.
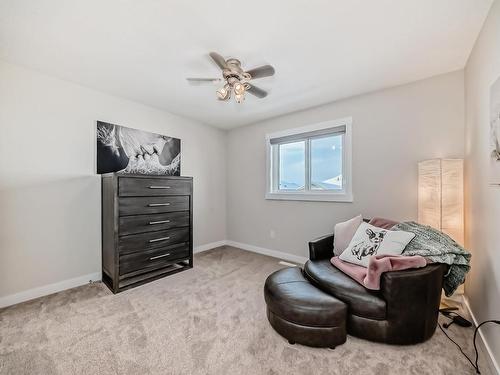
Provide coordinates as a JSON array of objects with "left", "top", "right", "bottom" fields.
[{"left": 0, "top": 247, "right": 487, "bottom": 375}]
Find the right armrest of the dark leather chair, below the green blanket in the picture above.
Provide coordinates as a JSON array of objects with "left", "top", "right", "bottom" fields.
[{"left": 380, "top": 264, "right": 446, "bottom": 340}]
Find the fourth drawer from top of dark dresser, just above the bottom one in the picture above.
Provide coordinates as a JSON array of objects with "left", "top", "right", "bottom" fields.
[{"left": 118, "top": 228, "right": 189, "bottom": 255}]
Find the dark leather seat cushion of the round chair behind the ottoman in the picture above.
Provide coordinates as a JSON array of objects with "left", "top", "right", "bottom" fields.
[{"left": 304, "top": 259, "right": 386, "bottom": 320}]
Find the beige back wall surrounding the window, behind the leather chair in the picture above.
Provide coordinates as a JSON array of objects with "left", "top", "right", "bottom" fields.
[{"left": 227, "top": 71, "right": 464, "bottom": 257}]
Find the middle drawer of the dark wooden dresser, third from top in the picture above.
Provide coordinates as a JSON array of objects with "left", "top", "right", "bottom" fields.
[{"left": 118, "top": 211, "right": 189, "bottom": 236}]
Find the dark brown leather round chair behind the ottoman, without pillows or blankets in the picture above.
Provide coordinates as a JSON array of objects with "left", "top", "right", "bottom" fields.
[{"left": 304, "top": 235, "right": 446, "bottom": 345}]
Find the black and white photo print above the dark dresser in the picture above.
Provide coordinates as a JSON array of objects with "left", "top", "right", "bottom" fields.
[{"left": 96, "top": 121, "right": 181, "bottom": 176}]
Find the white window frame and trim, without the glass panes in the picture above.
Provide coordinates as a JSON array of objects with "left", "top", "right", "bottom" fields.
[{"left": 265, "top": 117, "right": 353, "bottom": 202}]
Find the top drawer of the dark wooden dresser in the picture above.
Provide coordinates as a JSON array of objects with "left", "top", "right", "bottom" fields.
[{"left": 118, "top": 177, "right": 191, "bottom": 197}]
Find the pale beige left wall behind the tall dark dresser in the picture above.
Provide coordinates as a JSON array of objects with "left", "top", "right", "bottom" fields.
[{"left": 0, "top": 62, "right": 226, "bottom": 301}]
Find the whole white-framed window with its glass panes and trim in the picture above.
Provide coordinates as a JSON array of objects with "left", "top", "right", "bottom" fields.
[{"left": 266, "top": 118, "right": 352, "bottom": 202}]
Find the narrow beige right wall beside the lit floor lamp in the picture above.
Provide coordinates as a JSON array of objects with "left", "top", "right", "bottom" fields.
[{"left": 465, "top": 1, "right": 500, "bottom": 368}]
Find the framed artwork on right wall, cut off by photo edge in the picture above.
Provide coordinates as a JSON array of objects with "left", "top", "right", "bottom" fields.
[{"left": 489, "top": 77, "right": 500, "bottom": 185}]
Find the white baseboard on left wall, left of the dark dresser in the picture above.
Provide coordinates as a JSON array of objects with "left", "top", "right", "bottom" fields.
[{"left": 0, "top": 272, "right": 102, "bottom": 308}]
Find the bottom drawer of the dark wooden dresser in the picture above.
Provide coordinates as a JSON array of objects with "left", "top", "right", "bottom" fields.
[{"left": 120, "top": 244, "right": 189, "bottom": 276}]
